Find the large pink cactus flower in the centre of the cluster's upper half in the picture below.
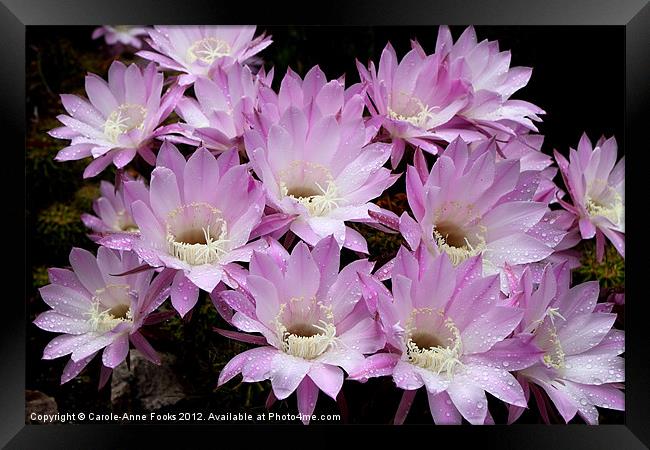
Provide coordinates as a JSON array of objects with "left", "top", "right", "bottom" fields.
[{"left": 244, "top": 69, "right": 397, "bottom": 253}]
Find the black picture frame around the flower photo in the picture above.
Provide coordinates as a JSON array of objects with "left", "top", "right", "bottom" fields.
[{"left": 5, "top": 0, "right": 650, "bottom": 450}]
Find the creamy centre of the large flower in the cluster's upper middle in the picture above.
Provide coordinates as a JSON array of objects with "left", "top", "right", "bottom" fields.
[{"left": 280, "top": 161, "right": 343, "bottom": 217}]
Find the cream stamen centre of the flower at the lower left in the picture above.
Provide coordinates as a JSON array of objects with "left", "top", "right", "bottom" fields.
[{"left": 86, "top": 285, "right": 136, "bottom": 333}]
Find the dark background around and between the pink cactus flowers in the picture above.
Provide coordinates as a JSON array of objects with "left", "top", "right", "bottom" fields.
[{"left": 26, "top": 26, "right": 625, "bottom": 423}]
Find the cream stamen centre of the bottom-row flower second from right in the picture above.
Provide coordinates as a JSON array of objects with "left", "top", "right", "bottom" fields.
[{"left": 406, "top": 309, "right": 463, "bottom": 376}]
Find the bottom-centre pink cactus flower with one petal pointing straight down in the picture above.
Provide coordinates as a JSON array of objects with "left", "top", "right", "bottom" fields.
[{"left": 219, "top": 237, "right": 385, "bottom": 424}]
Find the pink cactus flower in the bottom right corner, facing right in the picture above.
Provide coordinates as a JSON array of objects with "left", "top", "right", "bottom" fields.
[{"left": 509, "top": 264, "right": 625, "bottom": 424}]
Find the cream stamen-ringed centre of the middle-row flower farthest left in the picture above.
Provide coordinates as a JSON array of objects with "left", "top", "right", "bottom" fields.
[{"left": 167, "top": 202, "right": 230, "bottom": 266}]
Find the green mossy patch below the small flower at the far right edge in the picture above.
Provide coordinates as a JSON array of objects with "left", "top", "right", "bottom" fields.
[{"left": 574, "top": 240, "right": 625, "bottom": 290}]
